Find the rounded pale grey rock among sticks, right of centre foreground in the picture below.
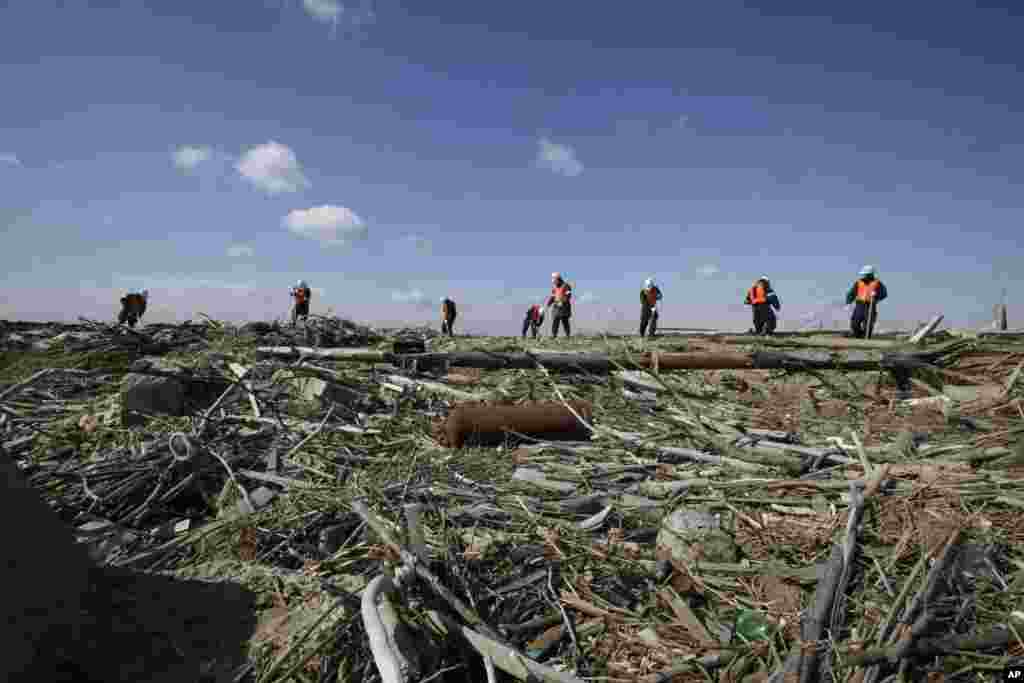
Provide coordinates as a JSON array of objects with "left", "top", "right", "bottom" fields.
[{"left": 657, "top": 508, "right": 738, "bottom": 564}]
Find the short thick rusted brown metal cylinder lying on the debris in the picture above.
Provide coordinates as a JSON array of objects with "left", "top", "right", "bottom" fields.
[{"left": 440, "top": 400, "right": 594, "bottom": 449}]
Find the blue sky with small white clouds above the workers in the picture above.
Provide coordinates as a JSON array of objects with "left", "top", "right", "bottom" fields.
[{"left": 0, "top": 0, "right": 1024, "bottom": 333}]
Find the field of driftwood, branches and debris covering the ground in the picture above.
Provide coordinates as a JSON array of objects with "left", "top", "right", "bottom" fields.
[{"left": 0, "top": 316, "right": 1024, "bottom": 683}]
